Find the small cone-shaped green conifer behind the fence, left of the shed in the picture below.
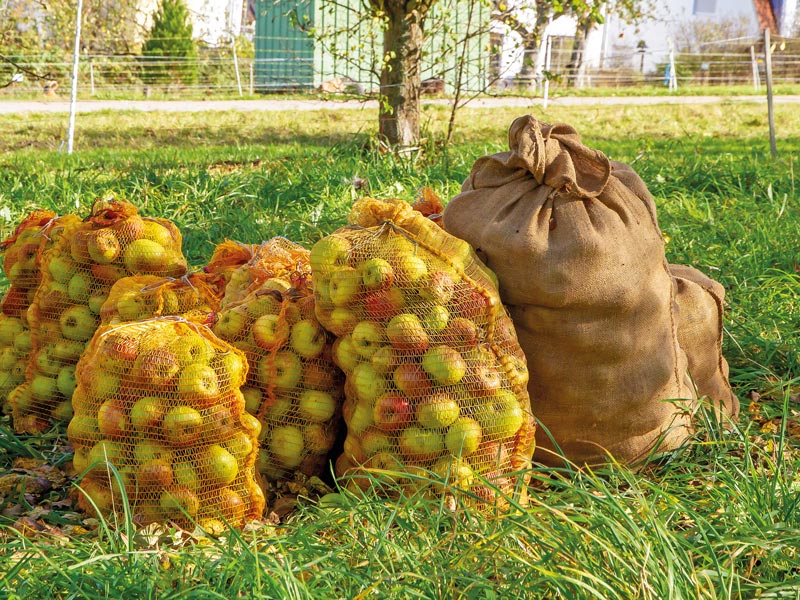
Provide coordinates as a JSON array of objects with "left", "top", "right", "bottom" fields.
[{"left": 142, "top": 0, "right": 197, "bottom": 83}]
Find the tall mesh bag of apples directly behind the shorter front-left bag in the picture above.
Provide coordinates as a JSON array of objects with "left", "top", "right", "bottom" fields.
[{"left": 12, "top": 199, "right": 186, "bottom": 433}]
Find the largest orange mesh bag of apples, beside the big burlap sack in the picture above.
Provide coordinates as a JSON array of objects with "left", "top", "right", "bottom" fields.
[{"left": 311, "top": 198, "right": 535, "bottom": 501}]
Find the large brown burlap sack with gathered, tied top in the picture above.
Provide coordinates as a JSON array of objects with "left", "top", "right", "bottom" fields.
[{"left": 444, "top": 116, "right": 695, "bottom": 464}]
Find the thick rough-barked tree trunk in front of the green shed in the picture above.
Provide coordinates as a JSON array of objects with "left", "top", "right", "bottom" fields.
[{"left": 378, "top": 2, "right": 425, "bottom": 147}]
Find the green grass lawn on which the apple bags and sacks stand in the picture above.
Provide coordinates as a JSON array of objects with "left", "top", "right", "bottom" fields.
[{"left": 0, "top": 104, "right": 800, "bottom": 600}]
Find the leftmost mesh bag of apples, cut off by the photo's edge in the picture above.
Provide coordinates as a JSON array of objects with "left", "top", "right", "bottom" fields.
[{"left": 0, "top": 210, "right": 56, "bottom": 413}]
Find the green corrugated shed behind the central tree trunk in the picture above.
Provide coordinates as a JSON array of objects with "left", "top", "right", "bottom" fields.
[{"left": 254, "top": 0, "right": 489, "bottom": 92}]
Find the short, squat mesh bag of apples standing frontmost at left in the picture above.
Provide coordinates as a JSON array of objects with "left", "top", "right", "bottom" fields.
[{"left": 67, "top": 317, "right": 264, "bottom": 531}]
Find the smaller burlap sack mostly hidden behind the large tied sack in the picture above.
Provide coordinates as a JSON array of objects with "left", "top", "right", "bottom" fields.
[{"left": 669, "top": 265, "right": 739, "bottom": 418}]
